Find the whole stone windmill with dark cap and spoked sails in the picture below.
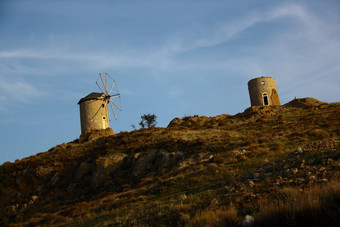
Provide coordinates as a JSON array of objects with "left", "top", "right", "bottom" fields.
[{"left": 78, "top": 73, "right": 121, "bottom": 136}]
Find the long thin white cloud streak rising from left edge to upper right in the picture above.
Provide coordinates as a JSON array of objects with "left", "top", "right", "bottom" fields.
[{"left": 0, "top": 4, "right": 311, "bottom": 66}]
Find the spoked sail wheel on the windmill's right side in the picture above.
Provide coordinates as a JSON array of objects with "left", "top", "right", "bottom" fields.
[{"left": 96, "top": 73, "right": 122, "bottom": 121}]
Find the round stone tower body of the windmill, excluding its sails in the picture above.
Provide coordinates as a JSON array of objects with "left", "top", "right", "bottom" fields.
[{"left": 78, "top": 92, "right": 109, "bottom": 134}]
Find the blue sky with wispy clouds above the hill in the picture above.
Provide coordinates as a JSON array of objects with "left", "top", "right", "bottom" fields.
[{"left": 0, "top": 0, "right": 340, "bottom": 164}]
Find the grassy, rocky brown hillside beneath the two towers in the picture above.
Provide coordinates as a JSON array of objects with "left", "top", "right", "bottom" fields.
[{"left": 0, "top": 98, "right": 340, "bottom": 226}]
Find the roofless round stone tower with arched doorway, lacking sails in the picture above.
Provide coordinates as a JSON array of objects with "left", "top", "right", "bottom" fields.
[{"left": 248, "top": 77, "right": 281, "bottom": 106}]
